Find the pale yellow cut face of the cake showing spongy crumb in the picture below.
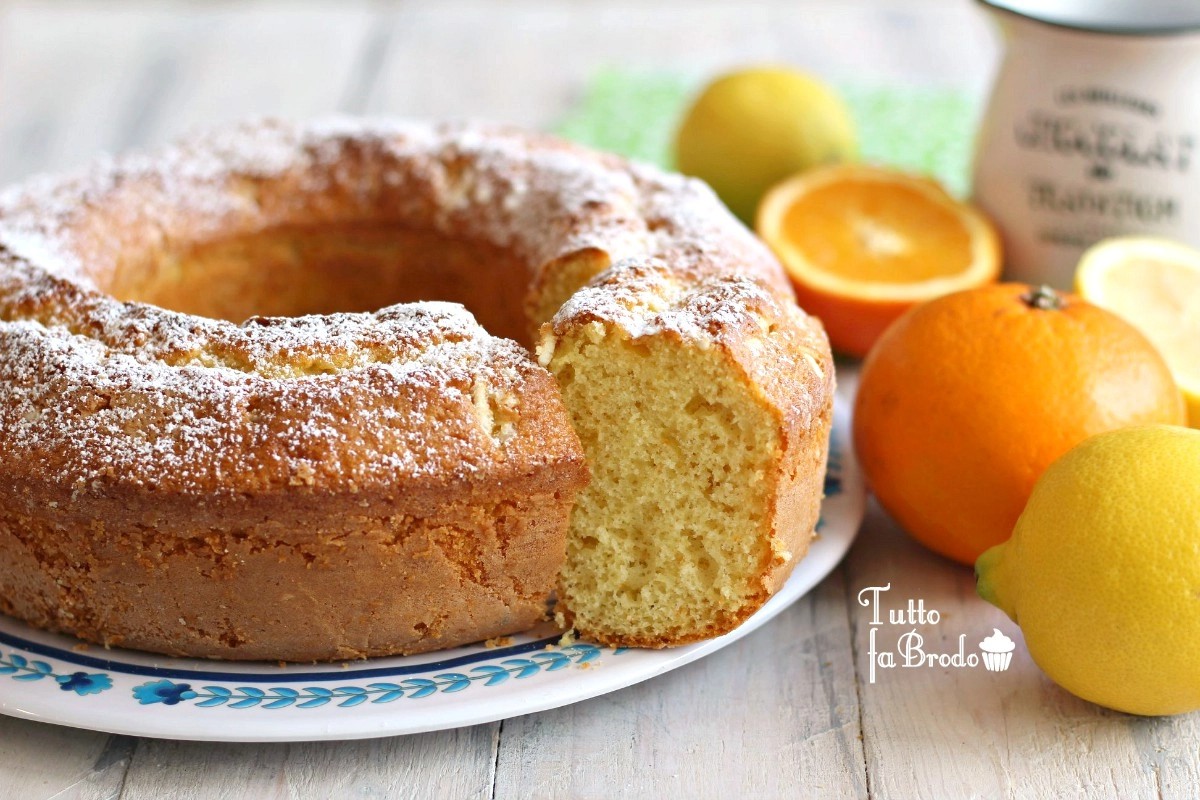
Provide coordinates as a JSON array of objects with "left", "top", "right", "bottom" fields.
[{"left": 551, "top": 327, "right": 779, "bottom": 642}]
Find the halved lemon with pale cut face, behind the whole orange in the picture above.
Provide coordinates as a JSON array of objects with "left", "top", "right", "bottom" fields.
[{"left": 1075, "top": 236, "right": 1200, "bottom": 428}]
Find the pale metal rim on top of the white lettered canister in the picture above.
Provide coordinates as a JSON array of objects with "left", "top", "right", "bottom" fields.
[{"left": 979, "top": 0, "right": 1200, "bottom": 35}]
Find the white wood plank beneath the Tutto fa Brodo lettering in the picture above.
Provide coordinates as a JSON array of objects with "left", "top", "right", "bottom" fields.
[{"left": 847, "top": 503, "right": 1171, "bottom": 799}]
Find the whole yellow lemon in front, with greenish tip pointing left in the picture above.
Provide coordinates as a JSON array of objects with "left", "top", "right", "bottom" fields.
[{"left": 976, "top": 425, "right": 1200, "bottom": 715}]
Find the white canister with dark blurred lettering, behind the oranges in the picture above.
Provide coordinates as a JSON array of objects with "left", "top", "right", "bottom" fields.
[{"left": 973, "top": 0, "right": 1200, "bottom": 288}]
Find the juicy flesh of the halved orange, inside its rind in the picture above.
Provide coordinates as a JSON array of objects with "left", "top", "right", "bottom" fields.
[{"left": 782, "top": 181, "right": 974, "bottom": 283}]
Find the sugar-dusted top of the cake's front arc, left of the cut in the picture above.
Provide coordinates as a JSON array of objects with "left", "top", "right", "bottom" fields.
[{"left": 0, "top": 306, "right": 549, "bottom": 491}]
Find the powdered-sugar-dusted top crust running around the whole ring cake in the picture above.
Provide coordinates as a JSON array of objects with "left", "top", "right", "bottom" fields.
[{"left": 0, "top": 118, "right": 787, "bottom": 492}]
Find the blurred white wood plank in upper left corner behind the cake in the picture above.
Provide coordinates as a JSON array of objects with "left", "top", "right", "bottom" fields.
[{"left": 0, "top": 0, "right": 376, "bottom": 182}]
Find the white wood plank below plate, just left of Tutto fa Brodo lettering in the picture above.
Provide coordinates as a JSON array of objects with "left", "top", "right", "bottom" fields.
[{"left": 496, "top": 572, "right": 866, "bottom": 800}]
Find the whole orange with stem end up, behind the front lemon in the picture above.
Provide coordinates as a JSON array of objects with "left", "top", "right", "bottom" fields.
[{"left": 854, "top": 283, "right": 1186, "bottom": 564}]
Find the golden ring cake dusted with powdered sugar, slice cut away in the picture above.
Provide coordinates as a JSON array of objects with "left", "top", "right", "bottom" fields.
[{"left": 0, "top": 119, "right": 833, "bottom": 661}]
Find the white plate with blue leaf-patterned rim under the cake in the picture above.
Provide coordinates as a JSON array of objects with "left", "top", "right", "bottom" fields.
[{"left": 0, "top": 398, "right": 865, "bottom": 741}]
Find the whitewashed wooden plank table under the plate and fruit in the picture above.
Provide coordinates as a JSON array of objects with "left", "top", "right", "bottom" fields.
[{"left": 0, "top": 0, "right": 1200, "bottom": 800}]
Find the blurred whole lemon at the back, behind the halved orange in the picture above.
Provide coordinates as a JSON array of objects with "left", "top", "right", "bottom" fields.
[{"left": 676, "top": 67, "right": 857, "bottom": 224}]
